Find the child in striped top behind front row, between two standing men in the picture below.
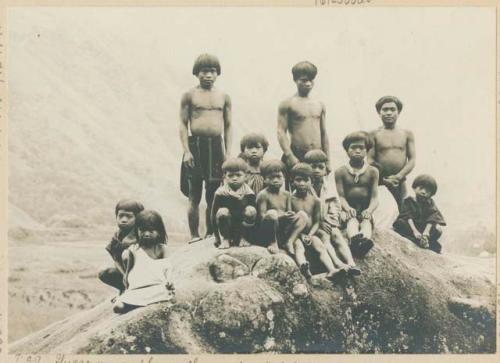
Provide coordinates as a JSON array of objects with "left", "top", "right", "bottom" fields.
[{"left": 240, "top": 133, "right": 269, "bottom": 195}]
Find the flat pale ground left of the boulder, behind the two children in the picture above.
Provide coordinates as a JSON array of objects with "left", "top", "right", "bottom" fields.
[{"left": 8, "top": 230, "right": 186, "bottom": 342}]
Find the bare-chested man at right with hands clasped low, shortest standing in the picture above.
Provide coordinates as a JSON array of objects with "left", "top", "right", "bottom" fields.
[{"left": 368, "top": 96, "right": 415, "bottom": 208}]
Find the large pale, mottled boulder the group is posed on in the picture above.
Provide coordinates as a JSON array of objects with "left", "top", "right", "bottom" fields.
[{"left": 10, "top": 231, "right": 495, "bottom": 354}]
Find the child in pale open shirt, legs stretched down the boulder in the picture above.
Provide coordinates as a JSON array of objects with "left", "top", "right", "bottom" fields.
[{"left": 304, "top": 149, "right": 361, "bottom": 275}]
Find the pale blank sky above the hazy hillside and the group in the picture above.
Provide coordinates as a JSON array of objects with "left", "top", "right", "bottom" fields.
[{"left": 8, "top": 7, "right": 496, "bottom": 230}]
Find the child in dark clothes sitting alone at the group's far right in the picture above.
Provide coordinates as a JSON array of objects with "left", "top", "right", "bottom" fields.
[{"left": 393, "top": 175, "right": 446, "bottom": 253}]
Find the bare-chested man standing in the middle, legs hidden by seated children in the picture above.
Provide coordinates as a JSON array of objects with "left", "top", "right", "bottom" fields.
[{"left": 278, "top": 62, "right": 330, "bottom": 188}]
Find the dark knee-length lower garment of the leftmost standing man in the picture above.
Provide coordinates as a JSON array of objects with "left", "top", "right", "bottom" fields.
[{"left": 181, "top": 136, "right": 224, "bottom": 197}]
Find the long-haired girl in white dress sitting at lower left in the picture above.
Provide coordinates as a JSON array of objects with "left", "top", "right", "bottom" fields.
[{"left": 113, "top": 210, "right": 174, "bottom": 314}]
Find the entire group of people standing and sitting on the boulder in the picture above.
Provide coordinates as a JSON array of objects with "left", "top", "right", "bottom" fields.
[{"left": 99, "top": 54, "right": 445, "bottom": 312}]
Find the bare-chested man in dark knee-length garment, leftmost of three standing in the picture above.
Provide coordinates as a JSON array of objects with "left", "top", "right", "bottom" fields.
[{"left": 180, "top": 54, "right": 231, "bottom": 242}]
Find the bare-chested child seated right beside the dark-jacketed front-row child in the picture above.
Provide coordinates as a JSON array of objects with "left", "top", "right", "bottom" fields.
[{"left": 257, "top": 159, "right": 307, "bottom": 253}]
